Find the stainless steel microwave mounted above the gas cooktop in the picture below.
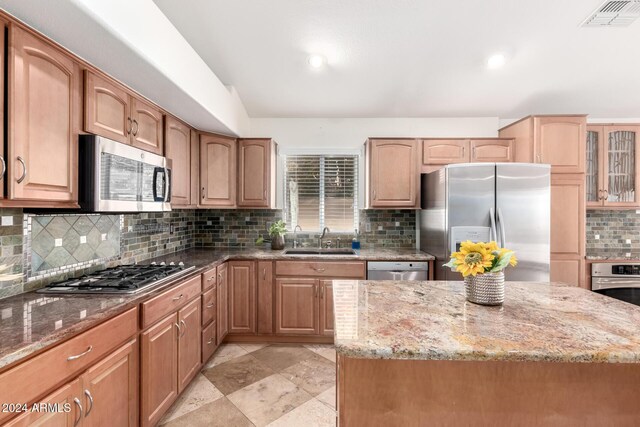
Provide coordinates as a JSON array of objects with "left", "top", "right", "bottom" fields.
[{"left": 79, "top": 135, "right": 171, "bottom": 212}]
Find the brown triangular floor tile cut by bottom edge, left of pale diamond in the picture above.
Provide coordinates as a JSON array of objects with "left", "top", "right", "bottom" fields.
[{"left": 164, "top": 397, "right": 253, "bottom": 427}]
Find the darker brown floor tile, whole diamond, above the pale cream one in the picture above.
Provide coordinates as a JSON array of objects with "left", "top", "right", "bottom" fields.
[{"left": 202, "top": 354, "right": 274, "bottom": 396}]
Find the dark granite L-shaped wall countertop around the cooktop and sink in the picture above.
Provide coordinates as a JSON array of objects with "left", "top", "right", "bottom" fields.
[{"left": 0, "top": 249, "right": 434, "bottom": 370}]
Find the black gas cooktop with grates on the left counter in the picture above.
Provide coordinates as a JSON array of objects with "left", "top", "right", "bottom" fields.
[{"left": 38, "top": 263, "right": 195, "bottom": 294}]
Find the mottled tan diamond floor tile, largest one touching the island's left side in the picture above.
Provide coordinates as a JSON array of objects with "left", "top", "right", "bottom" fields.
[{"left": 280, "top": 357, "right": 336, "bottom": 396}]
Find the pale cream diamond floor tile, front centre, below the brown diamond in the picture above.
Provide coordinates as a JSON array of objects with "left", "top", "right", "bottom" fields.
[{"left": 227, "top": 374, "right": 312, "bottom": 426}]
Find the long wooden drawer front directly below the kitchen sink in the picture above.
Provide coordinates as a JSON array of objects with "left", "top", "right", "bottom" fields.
[{"left": 276, "top": 261, "right": 365, "bottom": 279}]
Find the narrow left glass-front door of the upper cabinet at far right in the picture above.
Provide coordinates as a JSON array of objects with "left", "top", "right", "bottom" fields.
[{"left": 585, "top": 126, "right": 605, "bottom": 207}]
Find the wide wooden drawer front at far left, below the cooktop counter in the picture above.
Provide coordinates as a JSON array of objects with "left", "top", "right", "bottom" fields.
[{"left": 0, "top": 308, "right": 138, "bottom": 422}]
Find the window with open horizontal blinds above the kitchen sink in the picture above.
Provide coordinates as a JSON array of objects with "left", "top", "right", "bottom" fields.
[{"left": 284, "top": 155, "right": 358, "bottom": 232}]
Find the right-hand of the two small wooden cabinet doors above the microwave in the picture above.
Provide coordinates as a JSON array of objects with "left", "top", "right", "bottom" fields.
[{"left": 131, "top": 97, "right": 164, "bottom": 155}]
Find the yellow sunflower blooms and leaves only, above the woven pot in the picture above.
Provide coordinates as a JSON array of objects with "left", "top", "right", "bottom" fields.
[{"left": 444, "top": 240, "right": 518, "bottom": 277}]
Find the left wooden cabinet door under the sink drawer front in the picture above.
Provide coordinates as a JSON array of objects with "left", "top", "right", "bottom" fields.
[{"left": 276, "top": 278, "right": 320, "bottom": 335}]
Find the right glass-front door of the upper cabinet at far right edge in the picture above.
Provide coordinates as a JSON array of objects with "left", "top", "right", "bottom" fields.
[{"left": 602, "top": 126, "right": 640, "bottom": 207}]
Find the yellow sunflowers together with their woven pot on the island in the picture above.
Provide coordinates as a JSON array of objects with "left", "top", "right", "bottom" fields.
[{"left": 444, "top": 240, "right": 518, "bottom": 305}]
